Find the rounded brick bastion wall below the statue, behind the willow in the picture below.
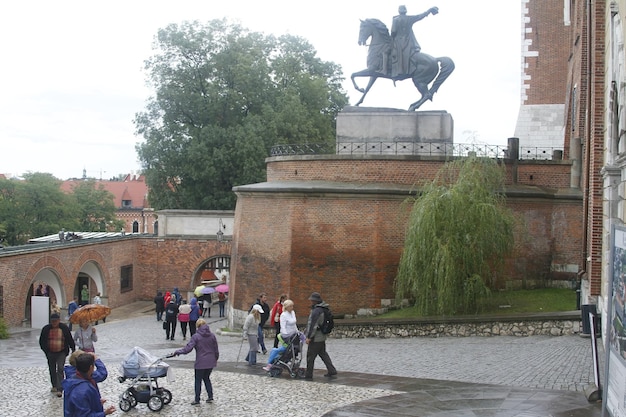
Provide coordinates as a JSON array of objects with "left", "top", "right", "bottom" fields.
[{"left": 231, "top": 156, "right": 582, "bottom": 314}]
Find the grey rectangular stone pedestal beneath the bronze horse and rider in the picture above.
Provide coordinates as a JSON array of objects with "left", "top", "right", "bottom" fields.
[{"left": 337, "top": 107, "right": 454, "bottom": 155}]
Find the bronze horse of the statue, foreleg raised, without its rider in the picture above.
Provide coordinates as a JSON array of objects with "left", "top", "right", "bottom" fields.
[{"left": 350, "top": 19, "right": 454, "bottom": 111}]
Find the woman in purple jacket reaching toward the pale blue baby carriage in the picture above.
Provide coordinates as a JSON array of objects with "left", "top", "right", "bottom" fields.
[{"left": 174, "top": 319, "right": 220, "bottom": 405}]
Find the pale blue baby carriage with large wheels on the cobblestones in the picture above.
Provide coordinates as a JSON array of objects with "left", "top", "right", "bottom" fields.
[{"left": 118, "top": 347, "right": 172, "bottom": 411}]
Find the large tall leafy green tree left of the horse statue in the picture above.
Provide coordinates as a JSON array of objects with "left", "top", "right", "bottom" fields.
[{"left": 135, "top": 20, "right": 348, "bottom": 209}]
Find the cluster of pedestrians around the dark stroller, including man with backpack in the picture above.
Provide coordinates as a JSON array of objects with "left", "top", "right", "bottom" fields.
[{"left": 242, "top": 292, "right": 337, "bottom": 380}]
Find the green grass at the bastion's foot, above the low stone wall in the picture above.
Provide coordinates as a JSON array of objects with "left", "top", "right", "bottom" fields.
[{"left": 377, "top": 288, "right": 576, "bottom": 318}]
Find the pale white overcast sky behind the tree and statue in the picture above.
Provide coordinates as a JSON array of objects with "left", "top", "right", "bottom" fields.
[{"left": 0, "top": 0, "right": 522, "bottom": 179}]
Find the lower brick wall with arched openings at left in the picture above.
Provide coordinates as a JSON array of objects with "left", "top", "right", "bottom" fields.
[{"left": 0, "top": 236, "right": 230, "bottom": 326}]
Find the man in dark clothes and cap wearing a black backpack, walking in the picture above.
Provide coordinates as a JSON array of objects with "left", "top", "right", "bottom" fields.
[{"left": 304, "top": 292, "right": 337, "bottom": 380}]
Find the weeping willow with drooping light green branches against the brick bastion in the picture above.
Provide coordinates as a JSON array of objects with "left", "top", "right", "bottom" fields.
[{"left": 395, "top": 158, "right": 515, "bottom": 315}]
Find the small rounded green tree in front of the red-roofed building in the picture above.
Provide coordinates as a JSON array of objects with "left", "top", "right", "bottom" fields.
[{"left": 70, "top": 180, "right": 124, "bottom": 232}]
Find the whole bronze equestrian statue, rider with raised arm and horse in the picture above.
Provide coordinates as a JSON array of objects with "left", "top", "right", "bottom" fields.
[{"left": 350, "top": 6, "right": 454, "bottom": 111}]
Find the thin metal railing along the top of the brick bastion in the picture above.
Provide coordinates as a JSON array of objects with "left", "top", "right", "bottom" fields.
[{"left": 270, "top": 141, "right": 563, "bottom": 160}]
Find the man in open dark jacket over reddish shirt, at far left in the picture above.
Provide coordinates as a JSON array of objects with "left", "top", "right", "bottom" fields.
[{"left": 39, "top": 313, "right": 76, "bottom": 397}]
